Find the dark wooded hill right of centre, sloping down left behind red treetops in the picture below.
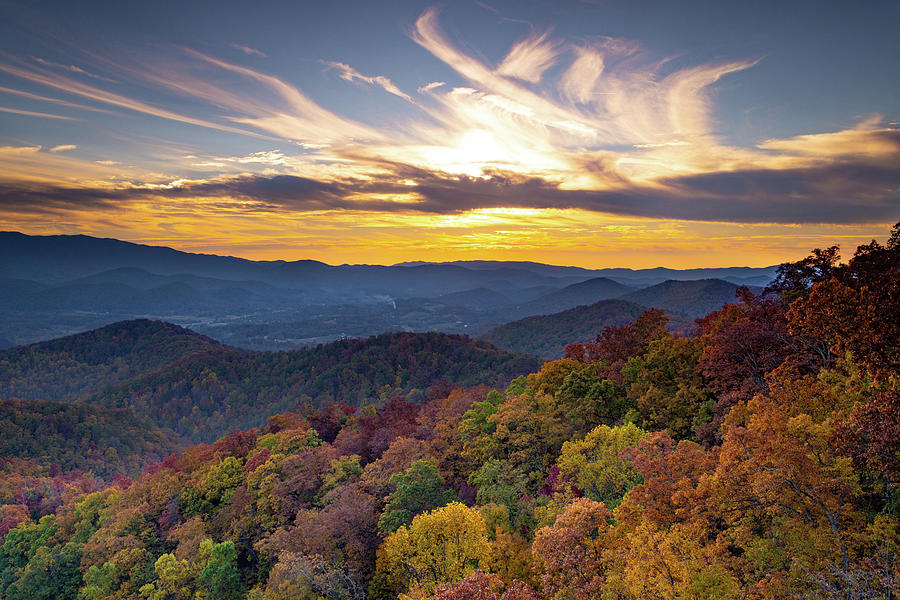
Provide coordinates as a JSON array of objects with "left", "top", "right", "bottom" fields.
[{"left": 479, "top": 299, "right": 645, "bottom": 360}]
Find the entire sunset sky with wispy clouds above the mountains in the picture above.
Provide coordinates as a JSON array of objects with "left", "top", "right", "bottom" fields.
[{"left": 0, "top": 0, "right": 900, "bottom": 268}]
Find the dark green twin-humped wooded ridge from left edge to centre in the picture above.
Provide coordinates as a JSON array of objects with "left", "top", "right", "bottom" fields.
[{"left": 0, "top": 320, "right": 540, "bottom": 441}]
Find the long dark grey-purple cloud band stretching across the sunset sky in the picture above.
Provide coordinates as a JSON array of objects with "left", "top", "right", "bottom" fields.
[{"left": 0, "top": 157, "right": 900, "bottom": 224}]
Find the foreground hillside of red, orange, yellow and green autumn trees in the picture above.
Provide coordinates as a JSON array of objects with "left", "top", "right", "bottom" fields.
[{"left": 0, "top": 224, "right": 900, "bottom": 600}]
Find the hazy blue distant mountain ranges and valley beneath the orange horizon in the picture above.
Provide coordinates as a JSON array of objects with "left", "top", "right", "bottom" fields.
[{"left": 0, "top": 232, "right": 775, "bottom": 350}]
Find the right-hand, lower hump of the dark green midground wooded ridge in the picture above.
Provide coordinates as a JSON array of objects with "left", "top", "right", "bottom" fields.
[{"left": 85, "top": 333, "right": 541, "bottom": 441}]
